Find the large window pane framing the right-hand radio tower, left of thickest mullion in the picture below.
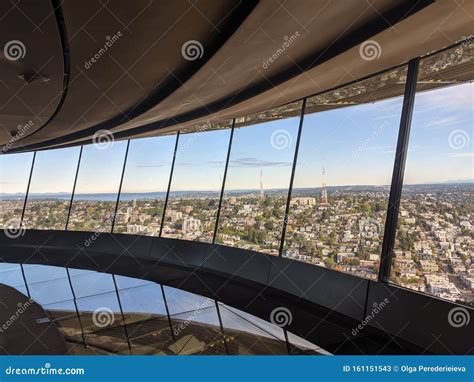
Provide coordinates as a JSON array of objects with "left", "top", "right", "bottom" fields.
[{"left": 283, "top": 67, "right": 406, "bottom": 278}]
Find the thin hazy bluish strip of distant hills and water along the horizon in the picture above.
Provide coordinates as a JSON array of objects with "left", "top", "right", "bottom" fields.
[{"left": 0, "top": 179, "right": 474, "bottom": 201}]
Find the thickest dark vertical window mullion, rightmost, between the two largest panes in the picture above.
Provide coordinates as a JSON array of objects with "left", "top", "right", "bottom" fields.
[{"left": 378, "top": 58, "right": 420, "bottom": 282}]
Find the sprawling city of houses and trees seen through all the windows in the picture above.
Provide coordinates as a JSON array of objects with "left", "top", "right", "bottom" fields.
[{"left": 2, "top": 178, "right": 474, "bottom": 305}]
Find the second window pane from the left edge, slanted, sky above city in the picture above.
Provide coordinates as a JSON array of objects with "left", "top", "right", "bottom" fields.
[{"left": 23, "top": 147, "right": 80, "bottom": 230}]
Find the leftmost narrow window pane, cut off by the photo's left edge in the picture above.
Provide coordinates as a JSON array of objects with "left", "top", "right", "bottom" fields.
[{"left": 0, "top": 153, "right": 33, "bottom": 228}]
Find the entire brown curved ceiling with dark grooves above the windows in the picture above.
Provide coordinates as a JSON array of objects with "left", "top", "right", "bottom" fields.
[{"left": 0, "top": 0, "right": 474, "bottom": 152}]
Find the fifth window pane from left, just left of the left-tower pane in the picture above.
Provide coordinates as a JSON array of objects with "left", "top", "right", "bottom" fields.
[{"left": 163, "top": 129, "right": 230, "bottom": 242}]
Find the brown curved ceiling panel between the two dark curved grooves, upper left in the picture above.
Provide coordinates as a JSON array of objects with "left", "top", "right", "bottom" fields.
[{"left": 4, "top": 0, "right": 256, "bottom": 151}]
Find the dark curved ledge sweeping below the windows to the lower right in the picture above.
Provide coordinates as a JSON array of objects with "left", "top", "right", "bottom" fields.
[{"left": 0, "top": 230, "right": 472, "bottom": 354}]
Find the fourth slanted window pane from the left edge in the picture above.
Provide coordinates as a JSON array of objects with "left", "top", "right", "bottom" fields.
[{"left": 114, "top": 136, "right": 176, "bottom": 236}]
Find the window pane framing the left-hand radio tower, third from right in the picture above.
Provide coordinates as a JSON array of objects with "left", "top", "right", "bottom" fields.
[{"left": 217, "top": 102, "right": 301, "bottom": 255}]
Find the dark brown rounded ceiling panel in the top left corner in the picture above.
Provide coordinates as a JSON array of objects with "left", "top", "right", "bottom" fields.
[{"left": 0, "top": 0, "right": 64, "bottom": 147}]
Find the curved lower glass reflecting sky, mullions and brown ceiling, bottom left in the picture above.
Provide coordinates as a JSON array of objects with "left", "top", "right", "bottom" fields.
[{"left": 0, "top": 263, "right": 324, "bottom": 355}]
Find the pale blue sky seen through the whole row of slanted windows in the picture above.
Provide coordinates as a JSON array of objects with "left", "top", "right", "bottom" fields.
[{"left": 0, "top": 83, "right": 474, "bottom": 193}]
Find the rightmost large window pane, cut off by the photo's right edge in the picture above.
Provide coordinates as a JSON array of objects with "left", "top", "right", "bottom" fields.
[{"left": 391, "top": 44, "right": 474, "bottom": 304}]
